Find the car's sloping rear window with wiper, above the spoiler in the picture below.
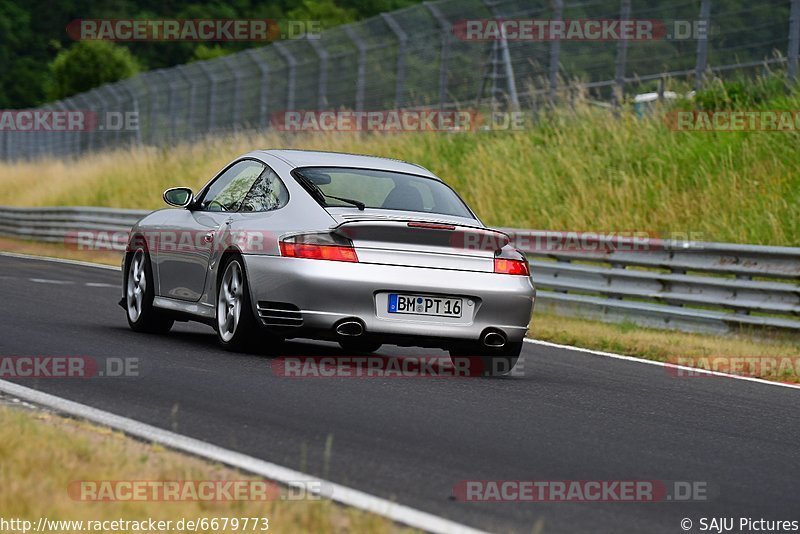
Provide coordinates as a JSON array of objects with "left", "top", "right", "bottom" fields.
[{"left": 295, "top": 167, "right": 474, "bottom": 219}]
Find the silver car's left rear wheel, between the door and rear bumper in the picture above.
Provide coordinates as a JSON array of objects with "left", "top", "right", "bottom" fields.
[{"left": 214, "top": 255, "right": 258, "bottom": 352}]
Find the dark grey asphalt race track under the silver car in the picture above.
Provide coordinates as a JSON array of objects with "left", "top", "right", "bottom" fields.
[{"left": 0, "top": 257, "right": 800, "bottom": 533}]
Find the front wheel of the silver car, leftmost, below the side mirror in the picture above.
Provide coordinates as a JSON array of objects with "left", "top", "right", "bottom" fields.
[{"left": 124, "top": 245, "right": 175, "bottom": 334}]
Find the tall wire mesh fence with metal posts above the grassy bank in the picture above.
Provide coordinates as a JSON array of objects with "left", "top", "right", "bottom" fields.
[{"left": 0, "top": 0, "right": 800, "bottom": 160}]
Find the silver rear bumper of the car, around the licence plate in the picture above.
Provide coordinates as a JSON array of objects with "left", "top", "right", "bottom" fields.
[{"left": 244, "top": 255, "right": 536, "bottom": 346}]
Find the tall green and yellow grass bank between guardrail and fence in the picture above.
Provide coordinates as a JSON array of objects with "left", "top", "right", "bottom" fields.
[{"left": 0, "top": 101, "right": 800, "bottom": 246}]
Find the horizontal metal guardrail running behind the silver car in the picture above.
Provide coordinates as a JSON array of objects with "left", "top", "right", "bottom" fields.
[{"left": 0, "top": 206, "right": 800, "bottom": 333}]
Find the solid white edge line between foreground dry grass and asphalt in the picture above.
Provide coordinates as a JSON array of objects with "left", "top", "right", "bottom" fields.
[{"left": 0, "top": 380, "right": 483, "bottom": 534}]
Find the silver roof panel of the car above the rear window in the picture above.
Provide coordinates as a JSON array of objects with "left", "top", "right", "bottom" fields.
[{"left": 258, "top": 149, "right": 439, "bottom": 180}]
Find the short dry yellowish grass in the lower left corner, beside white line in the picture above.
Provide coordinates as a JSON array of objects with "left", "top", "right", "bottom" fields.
[{"left": 0, "top": 406, "right": 410, "bottom": 533}]
